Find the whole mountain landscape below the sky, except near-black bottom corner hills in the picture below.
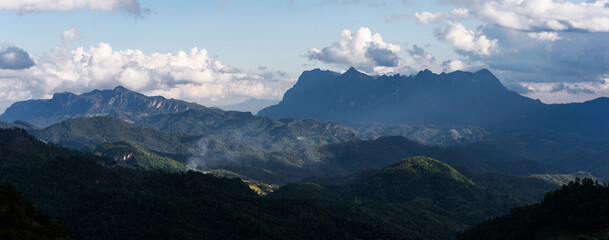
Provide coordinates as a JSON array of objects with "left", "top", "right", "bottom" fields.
[{"left": 0, "top": 69, "right": 609, "bottom": 239}]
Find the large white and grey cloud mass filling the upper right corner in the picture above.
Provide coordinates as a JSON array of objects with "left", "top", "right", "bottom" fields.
[{"left": 414, "top": 0, "right": 609, "bottom": 102}]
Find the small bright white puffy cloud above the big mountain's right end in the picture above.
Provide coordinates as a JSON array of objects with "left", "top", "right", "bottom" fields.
[{"left": 434, "top": 21, "right": 497, "bottom": 56}]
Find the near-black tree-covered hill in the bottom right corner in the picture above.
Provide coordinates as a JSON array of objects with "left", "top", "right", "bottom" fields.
[{"left": 457, "top": 179, "right": 609, "bottom": 240}]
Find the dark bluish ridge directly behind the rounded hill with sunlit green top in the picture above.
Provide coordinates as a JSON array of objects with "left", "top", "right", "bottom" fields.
[{"left": 265, "top": 136, "right": 566, "bottom": 176}]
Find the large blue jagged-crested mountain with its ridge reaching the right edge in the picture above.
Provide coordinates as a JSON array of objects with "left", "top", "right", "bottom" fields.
[{"left": 258, "top": 68, "right": 609, "bottom": 136}]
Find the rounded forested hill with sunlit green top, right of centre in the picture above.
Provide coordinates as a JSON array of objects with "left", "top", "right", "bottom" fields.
[{"left": 269, "top": 157, "right": 522, "bottom": 239}]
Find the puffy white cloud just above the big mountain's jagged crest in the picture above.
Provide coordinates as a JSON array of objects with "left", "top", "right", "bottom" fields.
[{"left": 307, "top": 27, "right": 401, "bottom": 72}]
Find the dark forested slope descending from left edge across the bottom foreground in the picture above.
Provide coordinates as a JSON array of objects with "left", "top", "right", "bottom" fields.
[{"left": 0, "top": 129, "right": 407, "bottom": 240}]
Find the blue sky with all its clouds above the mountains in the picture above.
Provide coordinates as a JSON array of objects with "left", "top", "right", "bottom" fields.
[{"left": 0, "top": 0, "right": 609, "bottom": 112}]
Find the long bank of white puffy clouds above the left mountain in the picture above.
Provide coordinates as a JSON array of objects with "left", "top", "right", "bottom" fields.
[{"left": 0, "top": 43, "right": 293, "bottom": 109}]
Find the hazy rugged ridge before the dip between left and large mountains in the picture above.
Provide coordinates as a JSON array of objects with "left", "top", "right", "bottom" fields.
[{"left": 135, "top": 108, "right": 360, "bottom": 150}]
